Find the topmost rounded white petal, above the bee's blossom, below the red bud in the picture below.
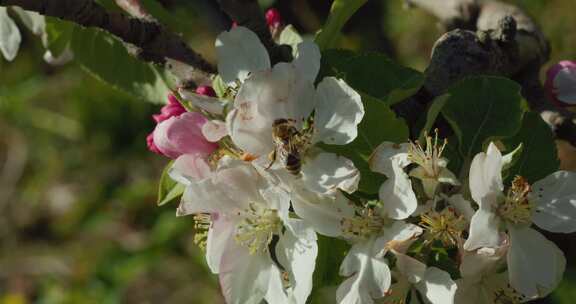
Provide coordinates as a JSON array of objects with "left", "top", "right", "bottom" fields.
[{"left": 216, "top": 26, "right": 270, "bottom": 84}]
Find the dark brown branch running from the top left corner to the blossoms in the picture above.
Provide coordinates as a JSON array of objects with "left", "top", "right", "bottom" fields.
[{"left": 0, "top": 0, "right": 216, "bottom": 83}]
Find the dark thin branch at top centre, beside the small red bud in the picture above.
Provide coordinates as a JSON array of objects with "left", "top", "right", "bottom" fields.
[{"left": 218, "top": 0, "right": 292, "bottom": 64}]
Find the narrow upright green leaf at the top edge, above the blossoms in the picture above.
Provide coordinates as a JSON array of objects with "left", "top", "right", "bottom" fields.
[{"left": 316, "top": 0, "right": 368, "bottom": 50}]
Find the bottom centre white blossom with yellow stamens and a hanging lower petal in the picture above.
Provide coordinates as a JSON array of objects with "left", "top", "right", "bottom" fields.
[{"left": 336, "top": 208, "right": 421, "bottom": 304}]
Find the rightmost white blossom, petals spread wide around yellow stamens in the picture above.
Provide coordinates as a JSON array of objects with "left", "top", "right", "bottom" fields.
[{"left": 464, "top": 143, "right": 576, "bottom": 299}]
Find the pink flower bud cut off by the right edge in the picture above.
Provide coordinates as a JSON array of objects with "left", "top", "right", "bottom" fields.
[{"left": 544, "top": 60, "right": 576, "bottom": 107}]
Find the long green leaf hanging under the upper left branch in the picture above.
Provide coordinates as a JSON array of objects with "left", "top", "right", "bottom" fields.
[{"left": 71, "top": 27, "right": 170, "bottom": 103}]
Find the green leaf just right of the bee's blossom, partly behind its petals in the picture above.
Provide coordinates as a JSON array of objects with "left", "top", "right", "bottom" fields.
[{"left": 322, "top": 96, "right": 409, "bottom": 194}]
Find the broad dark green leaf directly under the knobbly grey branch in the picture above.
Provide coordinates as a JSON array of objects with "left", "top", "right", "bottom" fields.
[{"left": 441, "top": 76, "right": 525, "bottom": 160}]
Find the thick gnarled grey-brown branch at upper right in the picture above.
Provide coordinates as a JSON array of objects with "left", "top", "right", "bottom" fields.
[{"left": 397, "top": 0, "right": 576, "bottom": 145}]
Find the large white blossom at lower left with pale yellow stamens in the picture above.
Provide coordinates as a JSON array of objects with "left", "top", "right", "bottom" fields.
[{"left": 173, "top": 158, "right": 318, "bottom": 304}]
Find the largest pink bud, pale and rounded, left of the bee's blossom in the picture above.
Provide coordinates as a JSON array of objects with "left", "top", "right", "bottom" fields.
[{"left": 153, "top": 112, "right": 218, "bottom": 158}]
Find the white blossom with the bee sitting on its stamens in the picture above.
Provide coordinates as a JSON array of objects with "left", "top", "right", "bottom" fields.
[{"left": 221, "top": 28, "right": 364, "bottom": 193}]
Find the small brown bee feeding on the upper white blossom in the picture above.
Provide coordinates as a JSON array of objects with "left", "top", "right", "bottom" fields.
[{"left": 266, "top": 118, "right": 308, "bottom": 175}]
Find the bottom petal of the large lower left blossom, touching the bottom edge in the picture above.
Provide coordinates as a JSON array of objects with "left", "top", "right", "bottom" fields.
[{"left": 219, "top": 242, "right": 276, "bottom": 304}]
